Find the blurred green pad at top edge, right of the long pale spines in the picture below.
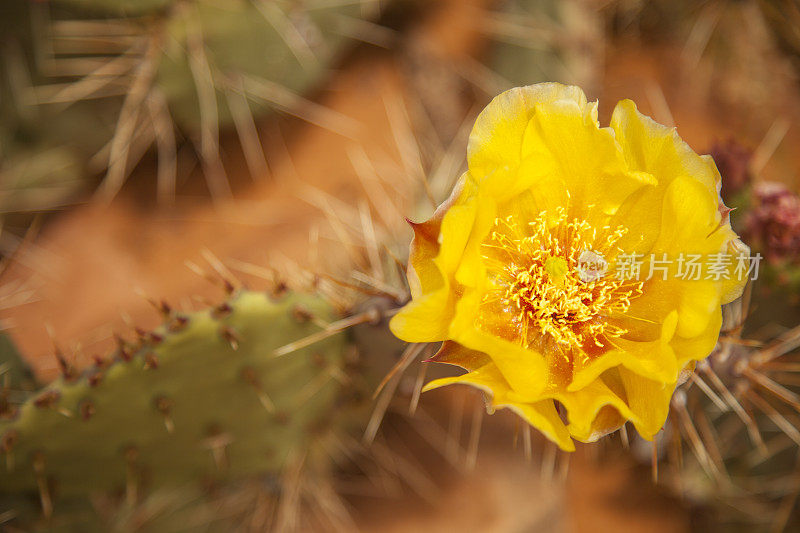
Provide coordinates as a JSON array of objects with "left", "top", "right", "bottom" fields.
[{"left": 156, "top": 0, "right": 361, "bottom": 131}]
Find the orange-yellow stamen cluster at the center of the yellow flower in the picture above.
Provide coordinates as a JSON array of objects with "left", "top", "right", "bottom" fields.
[{"left": 481, "top": 209, "right": 642, "bottom": 352}]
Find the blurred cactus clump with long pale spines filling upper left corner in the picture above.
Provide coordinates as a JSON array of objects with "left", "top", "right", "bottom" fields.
[{"left": 0, "top": 0, "right": 378, "bottom": 215}]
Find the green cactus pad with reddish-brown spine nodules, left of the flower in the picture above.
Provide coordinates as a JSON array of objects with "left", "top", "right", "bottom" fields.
[{"left": 0, "top": 292, "right": 382, "bottom": 528}]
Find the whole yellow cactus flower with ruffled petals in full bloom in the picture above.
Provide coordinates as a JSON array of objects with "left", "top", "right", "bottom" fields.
[{"left": 391, "top": 83, "right": 750, "bottom": 450}]
